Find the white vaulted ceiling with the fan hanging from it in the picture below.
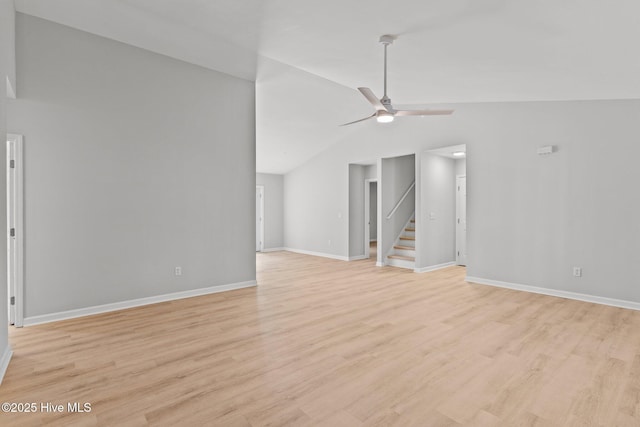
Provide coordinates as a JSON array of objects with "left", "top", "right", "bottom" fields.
[{"left": 15, "top": 0, "right": 640, "bottom": 173}]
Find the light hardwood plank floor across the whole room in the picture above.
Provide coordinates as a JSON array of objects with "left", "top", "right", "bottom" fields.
[{"left": 0, "top": 252, "right": 640, "bottom": 427}]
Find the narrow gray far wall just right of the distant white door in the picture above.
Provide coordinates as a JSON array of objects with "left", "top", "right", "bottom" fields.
[{"left": 256, "top": 173, "right": 284, "bottom": 250}]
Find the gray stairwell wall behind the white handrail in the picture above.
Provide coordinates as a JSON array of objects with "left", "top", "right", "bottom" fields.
[{"left": 378, "top": 154, "right": 416, "bottom": 262}]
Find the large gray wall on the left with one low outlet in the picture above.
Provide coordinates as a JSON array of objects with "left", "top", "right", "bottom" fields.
[{"left": 8, "top": 14, "right": 255, "bottom": 317}]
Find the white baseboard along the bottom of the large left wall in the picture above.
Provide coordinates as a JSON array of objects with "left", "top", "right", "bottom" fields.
[{"left": 24, "top": 280, "right": 257, "bottom": 326}]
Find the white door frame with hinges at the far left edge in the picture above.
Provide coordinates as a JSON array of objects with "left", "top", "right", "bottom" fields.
[{"left": 6, "top": 133, "right": 24, "bottom": 327}]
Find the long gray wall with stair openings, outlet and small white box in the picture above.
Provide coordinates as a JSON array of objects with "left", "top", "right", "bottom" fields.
[{"left": 285, "top": 100, "right": 640, "bottom": 302}]
